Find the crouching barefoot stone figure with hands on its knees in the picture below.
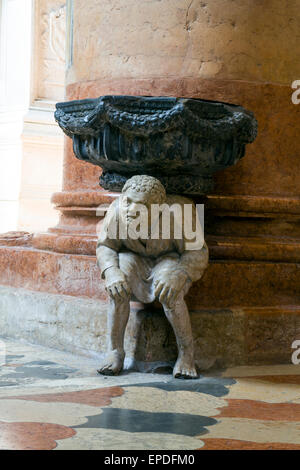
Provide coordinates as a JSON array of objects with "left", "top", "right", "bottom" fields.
[{"left": 97, "top": 175, "right": 208, "bottom": 379}]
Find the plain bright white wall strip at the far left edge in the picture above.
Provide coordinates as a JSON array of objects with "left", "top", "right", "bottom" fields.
[{"left": 0, "top": 0, "right": 32, "bottom": 233}]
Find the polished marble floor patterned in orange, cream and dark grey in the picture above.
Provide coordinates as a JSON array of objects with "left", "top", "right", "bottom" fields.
[{"left": 0, "top": 338, "right": 300, "bottom": 450}]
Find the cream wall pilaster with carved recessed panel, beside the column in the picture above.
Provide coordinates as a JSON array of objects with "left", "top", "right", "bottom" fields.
[{"left": 18, "top": 0, "right": 66, "bottom": 232}]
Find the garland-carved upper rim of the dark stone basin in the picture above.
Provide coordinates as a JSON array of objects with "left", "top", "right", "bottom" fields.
[{"left": 55, "top": 95, "right": 257, "bottom": 143}]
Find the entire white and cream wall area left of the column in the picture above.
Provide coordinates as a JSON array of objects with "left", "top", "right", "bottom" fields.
[{"left": 0, "top": 0, "right": 66, "bottom": 233}]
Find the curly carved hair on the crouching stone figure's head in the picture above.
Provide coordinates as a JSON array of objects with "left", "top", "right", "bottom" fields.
[{"left": 122, "top": 175, "right": 166, "bottom": 203}]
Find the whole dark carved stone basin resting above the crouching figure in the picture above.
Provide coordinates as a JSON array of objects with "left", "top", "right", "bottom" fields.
[{"left": 55, "top": 95, "right": 257, "bottom": 194}]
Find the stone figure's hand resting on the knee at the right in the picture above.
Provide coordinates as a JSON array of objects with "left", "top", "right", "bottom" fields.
[{"left": 154, "top": 271, "right": 189, "bottom": 305}]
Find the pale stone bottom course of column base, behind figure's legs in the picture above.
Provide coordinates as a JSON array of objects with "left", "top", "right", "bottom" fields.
[{"left": 0, "top": 285, "right": 300, "bottom": 372}]
